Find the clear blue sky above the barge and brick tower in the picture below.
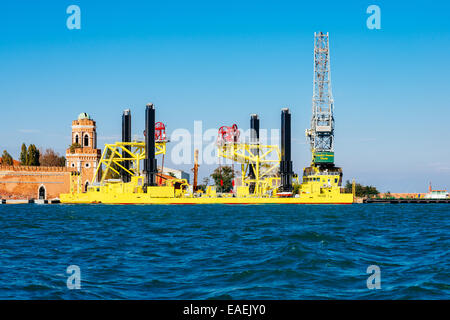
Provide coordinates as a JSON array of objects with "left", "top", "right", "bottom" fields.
[{"left": 0, "top": 0, "right": 450, "bottom": 192}]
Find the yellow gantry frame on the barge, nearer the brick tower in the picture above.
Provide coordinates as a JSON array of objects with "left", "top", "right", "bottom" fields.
[{"left": 92, "top": 141, "right": 166, "bottom": 184}]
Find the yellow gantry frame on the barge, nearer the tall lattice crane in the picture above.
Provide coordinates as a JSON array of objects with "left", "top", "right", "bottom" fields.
[{"left": 217, "top": 142, "right": 281, "bottom": 196}]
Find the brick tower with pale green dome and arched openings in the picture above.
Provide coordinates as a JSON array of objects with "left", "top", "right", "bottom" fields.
[{"left": 66, "top": 113, "right": 101, "bottom": 190}]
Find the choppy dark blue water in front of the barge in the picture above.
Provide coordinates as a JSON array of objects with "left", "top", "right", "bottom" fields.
[{"left": 0, "top": 204, "right": 450, "bottom": 299}]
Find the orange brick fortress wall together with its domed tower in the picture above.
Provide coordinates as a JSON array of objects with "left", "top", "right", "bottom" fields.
[{"left": 0, "top": 113, "right": 101, "bottom": 199}]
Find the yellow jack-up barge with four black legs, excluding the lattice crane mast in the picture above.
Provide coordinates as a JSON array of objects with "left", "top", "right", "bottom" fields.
[{"left": 60, "top": 104, "right": 354, "bottom": 204}]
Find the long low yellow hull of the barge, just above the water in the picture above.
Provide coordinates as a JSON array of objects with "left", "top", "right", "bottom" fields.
[{"left": 60, "top": 175, "right": 353, "bottom": 204}]
